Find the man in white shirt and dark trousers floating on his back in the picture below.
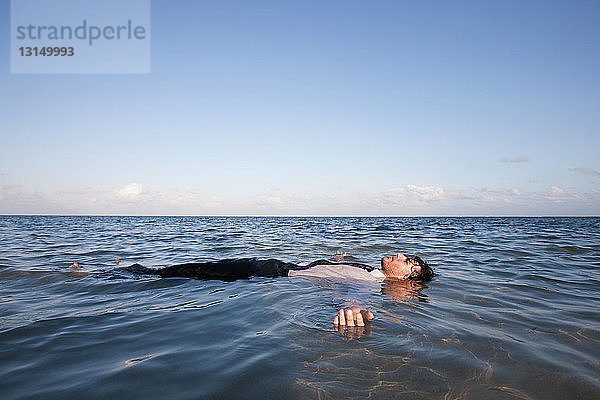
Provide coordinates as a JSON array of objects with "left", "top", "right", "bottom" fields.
[{"left": 127, "top": 252, "right": 433, "bottom": 326}]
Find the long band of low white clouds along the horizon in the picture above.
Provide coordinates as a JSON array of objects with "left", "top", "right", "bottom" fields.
[{"left": 0, "top": 182, "right": 600, "bottom": 215}]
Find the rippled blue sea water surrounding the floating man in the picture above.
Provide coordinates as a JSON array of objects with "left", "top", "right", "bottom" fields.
[{"left": 0, "top": 216, "right": 600, "bottom": 400}]
